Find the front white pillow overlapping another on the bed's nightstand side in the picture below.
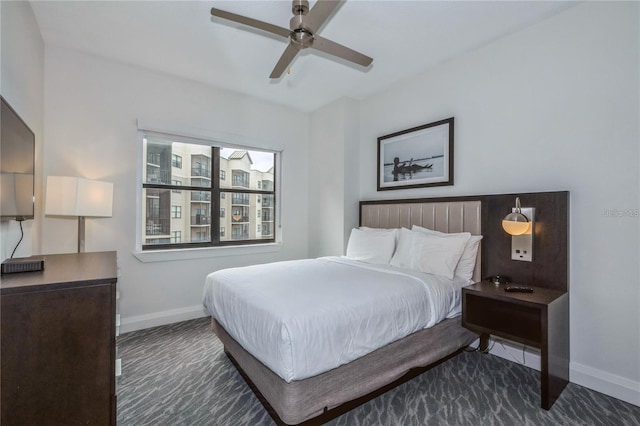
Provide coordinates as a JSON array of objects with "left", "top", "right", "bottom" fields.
[{"left": 413, "top": 232, "right": 471, "bottom": 279}]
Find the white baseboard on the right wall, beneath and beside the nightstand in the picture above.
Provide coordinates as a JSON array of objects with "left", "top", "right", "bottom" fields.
[{"left": 472, "top": 336, "right": 640, "bottom": 407}]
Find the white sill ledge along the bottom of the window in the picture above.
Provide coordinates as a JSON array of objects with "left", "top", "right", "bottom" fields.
[{"left": 133, "top": 243, "right": 282, "bottom": 263}]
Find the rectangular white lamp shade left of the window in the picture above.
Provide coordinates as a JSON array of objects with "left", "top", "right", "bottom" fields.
[{"left": 45, "top": 176, "right": 113, "bottom": 217}]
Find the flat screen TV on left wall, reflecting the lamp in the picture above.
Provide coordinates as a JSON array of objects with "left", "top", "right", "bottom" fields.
[{"left": 0, "top": 96, "right": 35, "bottom": 221}]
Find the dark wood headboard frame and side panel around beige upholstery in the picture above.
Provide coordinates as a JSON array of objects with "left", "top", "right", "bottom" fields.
[{"left": 360, "top": 191, "right": 569, "bottom": 291}]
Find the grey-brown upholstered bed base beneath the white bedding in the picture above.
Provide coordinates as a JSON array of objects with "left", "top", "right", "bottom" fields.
[{"left": 212, "top": 317, "right": 478, "bottom": 424}]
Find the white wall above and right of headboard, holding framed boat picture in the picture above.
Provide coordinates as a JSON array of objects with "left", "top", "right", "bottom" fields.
[{"left": 354, "top": 2, "right": 640, "bottom": 404}]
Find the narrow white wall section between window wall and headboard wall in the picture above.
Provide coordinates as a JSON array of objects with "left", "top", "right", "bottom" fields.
[{"left": 308, "top": 98, "right": 359, "bottom": 257}]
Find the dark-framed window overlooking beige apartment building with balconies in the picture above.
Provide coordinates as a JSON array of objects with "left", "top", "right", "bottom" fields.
[{"left": 140, "top": 132, "right": 277, "bottom": 250}]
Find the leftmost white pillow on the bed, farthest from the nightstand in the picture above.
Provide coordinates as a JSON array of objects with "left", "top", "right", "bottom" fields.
[{"left": 346, "top": 228, "right": 396, "bottom": 265}]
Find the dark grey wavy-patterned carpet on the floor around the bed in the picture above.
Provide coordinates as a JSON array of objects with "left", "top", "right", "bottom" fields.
[{"left": 117, "top": 318, "right": 640, "bottom": 426}]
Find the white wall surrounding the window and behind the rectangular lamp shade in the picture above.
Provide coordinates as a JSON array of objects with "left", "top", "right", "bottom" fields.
[{"left": 43, "top": 46, "right": 309, "bottom": 331}]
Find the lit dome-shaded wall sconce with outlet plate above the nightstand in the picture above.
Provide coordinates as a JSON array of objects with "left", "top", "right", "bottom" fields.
[{"left": 502, "top": 197, "right": 535, "bottom": 262}]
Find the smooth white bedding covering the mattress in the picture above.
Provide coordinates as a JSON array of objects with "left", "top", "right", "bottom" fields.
[{"left": 204, "top": 257, "right": 468, "bottom": 382}]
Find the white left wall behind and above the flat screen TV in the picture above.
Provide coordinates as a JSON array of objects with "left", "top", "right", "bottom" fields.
[{"left": 0, "top": 1, "right": 44, "bottom": 260}]
